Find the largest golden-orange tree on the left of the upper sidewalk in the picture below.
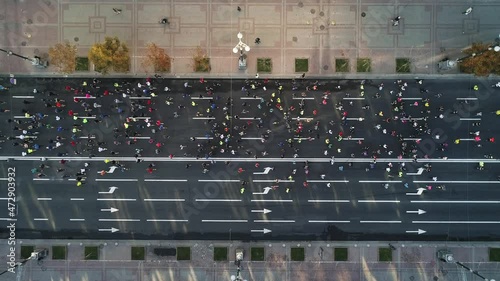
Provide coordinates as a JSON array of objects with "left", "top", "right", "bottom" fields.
[{"left": 89, "top": 37, "right": 130, "bottom": 74}]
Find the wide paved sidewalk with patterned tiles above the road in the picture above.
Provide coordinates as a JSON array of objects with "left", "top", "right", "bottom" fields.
[{"left": 0, "top": 0, "right": 500, "bottom": 78}]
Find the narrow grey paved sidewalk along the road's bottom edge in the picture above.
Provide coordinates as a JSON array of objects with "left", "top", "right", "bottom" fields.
[{"left": 0, "top": 240, "right": 500, "bottom": 281}]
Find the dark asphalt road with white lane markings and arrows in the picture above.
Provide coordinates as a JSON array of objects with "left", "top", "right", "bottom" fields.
[{"left": 0, "top": 76, "right": 500, "bottom": 241}]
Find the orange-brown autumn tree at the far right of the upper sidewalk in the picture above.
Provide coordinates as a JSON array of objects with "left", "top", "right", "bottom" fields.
[{"left": 460, "top": 43, "right": 500, "bottom": 76}]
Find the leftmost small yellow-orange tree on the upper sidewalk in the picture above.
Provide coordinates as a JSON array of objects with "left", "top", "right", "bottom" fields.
[{"left": 49, "top": 41, "right": 76, "bottom": 74}]
